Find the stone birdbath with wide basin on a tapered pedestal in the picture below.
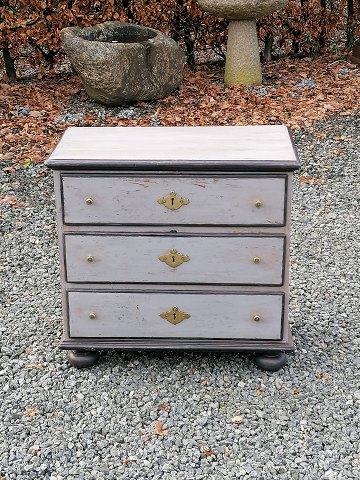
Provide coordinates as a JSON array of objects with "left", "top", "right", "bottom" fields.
[{"left": 198, "top": 0, "right": 288, "bottom": 86}]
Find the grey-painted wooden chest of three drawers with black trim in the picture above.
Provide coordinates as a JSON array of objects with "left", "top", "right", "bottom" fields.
[{"left": 46, "top": 126, "right": 299, "bottom": 370}]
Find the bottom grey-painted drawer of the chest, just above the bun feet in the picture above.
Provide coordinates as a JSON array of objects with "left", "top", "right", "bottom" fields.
[{"left": 68, "top": 291, "right": 284, "bottom": 340}]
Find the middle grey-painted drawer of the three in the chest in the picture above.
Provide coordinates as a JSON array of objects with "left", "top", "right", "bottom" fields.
[{"left": 65, "top": 234, "right": 285, "bottom": 285}]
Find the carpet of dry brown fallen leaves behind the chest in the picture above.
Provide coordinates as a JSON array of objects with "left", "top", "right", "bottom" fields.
[{"left": 0, "top": 55, "right": 360, "bottom": 169}]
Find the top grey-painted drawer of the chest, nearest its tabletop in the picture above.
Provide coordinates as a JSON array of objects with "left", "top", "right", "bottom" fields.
[{"left": 62, "top": 174, "right": 287, "bottom": 226}]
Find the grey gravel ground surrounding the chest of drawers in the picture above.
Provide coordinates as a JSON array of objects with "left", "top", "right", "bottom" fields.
[{"left": 0, "top": 113, "right": 360, "bottom": 480}]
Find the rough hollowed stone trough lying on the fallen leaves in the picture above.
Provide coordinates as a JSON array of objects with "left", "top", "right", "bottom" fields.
[{"left": 60, "top": 22, "right": 185, "bottom": 106}]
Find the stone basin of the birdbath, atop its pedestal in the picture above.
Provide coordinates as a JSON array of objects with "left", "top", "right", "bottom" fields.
[{"left": 198, "top": 0, "right": 288, "bottom": 20}]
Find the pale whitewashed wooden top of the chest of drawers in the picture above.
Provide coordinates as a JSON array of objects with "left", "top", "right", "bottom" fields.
[{"left": 46, "top": 125, "right": 300, "bottom": 171}]
